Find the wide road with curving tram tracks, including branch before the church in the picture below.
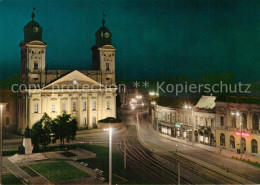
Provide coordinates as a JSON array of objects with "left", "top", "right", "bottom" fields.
[{"left": 3, "top": 108, "right": 260, "bottom": 184}]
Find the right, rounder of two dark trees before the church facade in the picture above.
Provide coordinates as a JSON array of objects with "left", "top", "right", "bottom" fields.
[{"left": 51, "top": 113, "right": 78, "bottom": 146}]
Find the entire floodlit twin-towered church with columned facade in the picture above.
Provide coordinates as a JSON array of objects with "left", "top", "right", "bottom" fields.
[{"left": 17, "top": 10, "right": 117, "bottom": 130}]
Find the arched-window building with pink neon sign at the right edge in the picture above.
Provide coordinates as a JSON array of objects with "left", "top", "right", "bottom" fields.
[{"left": 216, "top": 99, "right": 260, "bottom": 155}]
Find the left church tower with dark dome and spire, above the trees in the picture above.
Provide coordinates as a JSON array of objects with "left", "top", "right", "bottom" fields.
[{"left": 20, "top": 8, "right": 47, "bottom": 86}]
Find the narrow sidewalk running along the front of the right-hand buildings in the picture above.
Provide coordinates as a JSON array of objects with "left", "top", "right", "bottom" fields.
[{"left": 149, "top": 124, "right": 260, "bottom": 163}]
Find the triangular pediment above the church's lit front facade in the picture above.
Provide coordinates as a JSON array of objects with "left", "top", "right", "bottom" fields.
[{"left": 43, "top": 70, "right": 104, "bottom": 89}]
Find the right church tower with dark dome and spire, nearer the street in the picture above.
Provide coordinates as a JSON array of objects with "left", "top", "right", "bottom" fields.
[{"left": 91, "top": 14, "right": 116, "bottom": 84}]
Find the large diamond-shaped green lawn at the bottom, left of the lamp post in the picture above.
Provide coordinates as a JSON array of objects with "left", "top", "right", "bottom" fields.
[{"left": 30, "top": 161, "right": 90, "bottom": 183}]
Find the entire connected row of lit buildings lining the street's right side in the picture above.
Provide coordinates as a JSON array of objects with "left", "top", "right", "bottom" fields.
[{"left": 152, "top": 96, "right": 260, "bottom": 155}]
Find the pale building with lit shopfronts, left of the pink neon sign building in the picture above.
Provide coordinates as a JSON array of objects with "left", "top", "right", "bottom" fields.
[{"left": 153, "top": 96, "right": 216, "bottom": 146}]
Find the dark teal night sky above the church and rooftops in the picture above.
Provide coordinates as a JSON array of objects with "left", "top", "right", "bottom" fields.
[{"left": 0, "top": 0, "right": 260, "bottom": 81}]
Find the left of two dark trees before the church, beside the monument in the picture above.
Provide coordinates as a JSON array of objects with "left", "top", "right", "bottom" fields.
[{"left": 30, "top": 113, "right": 52, "bottom": 151}]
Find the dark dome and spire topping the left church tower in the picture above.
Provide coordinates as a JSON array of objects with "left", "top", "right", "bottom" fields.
[{"left": 24, "top": 8, "right": 42, "bottom": 43}]
